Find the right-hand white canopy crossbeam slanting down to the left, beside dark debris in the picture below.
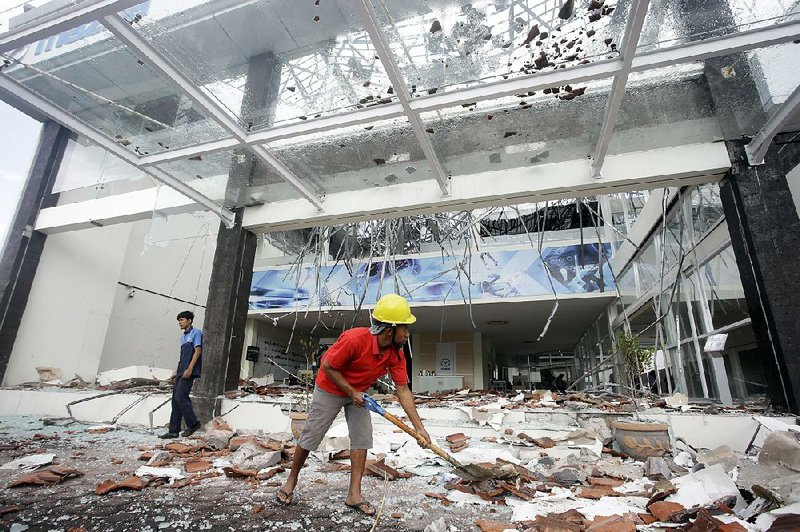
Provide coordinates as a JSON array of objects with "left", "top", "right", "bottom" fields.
[{"left": 589, "top": 0, "right": 650, "bottom": 179}]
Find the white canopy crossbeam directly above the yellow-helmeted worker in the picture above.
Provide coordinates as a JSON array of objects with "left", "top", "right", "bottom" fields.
[{"left": 356, "top": 0, "right": 450, "bottom": 196}]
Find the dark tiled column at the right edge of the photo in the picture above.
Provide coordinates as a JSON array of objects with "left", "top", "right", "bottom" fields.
[{"left": 720, "top": 135, "right": 800, "bottom": 413}]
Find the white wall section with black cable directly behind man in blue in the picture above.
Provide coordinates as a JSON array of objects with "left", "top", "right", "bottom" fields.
[{"left": 99, "top": 213, "right": 219, "bottom": 371}]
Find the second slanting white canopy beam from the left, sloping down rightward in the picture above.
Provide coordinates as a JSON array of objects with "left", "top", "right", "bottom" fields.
[{"left": 102, "top": 14, "right": 322, "bottom": 209}]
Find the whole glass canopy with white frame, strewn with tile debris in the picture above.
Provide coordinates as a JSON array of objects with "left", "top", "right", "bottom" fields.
[{"left": 0, "top": 0, "right": 800, "bottom": 220}]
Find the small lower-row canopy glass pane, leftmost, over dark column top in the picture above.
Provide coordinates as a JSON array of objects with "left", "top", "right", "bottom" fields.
[{"left": 158, "top": 148, "right": 301, "bottom": 208}]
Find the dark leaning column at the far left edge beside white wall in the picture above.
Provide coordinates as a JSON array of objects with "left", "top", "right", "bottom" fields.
[{"left": 0, "top": 122, "right": 70, "bottom": 376}]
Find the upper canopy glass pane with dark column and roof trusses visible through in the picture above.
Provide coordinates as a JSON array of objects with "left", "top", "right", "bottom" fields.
[{"left": 122, "top": 0, "right": 395, "bottom": 131}]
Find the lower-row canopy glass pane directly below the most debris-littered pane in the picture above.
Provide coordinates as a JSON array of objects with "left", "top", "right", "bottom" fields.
[{"left": 422, "top": 75, "right": 611, "bottom": 175}]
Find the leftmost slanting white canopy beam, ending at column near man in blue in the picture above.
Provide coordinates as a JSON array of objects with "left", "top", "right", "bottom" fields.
[{"left": 0, "top": 75, "right": 233, "bottom": 225}]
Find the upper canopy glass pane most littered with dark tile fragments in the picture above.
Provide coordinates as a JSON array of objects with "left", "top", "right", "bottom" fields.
[{"left": 372, "top": 0, "right": 627, "bottom": 96}]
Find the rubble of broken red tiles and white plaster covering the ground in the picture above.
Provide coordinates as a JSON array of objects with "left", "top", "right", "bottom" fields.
[{"left": 0, "top": 390, "right": 800, "bottom": 532}]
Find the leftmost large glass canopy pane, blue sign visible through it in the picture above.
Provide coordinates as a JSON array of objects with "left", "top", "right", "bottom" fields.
[{"left": 3, "top": 13, "right": 225, "bottom": 155}]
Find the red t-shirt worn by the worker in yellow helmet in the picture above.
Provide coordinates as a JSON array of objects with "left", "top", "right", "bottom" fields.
[{"left": 317, "top": 327, "right": 408, "bottom": 397}]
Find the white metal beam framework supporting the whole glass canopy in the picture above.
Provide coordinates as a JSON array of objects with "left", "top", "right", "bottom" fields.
[{"left": 0, "top": 0, "right": 800, "bottom": 224}]
